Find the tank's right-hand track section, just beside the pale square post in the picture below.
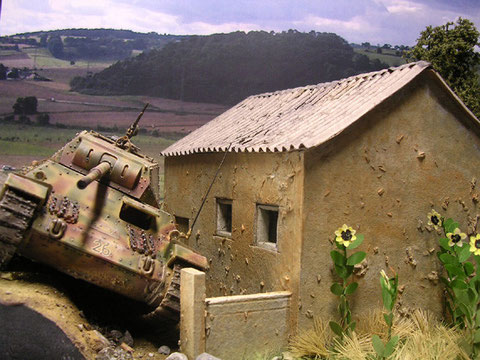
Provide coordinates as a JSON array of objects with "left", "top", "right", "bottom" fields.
[{"left": 145, "top": 264, "right": 183, "bottom": 321}]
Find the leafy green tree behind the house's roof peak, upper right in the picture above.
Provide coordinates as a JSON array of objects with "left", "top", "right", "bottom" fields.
[{"left": 407, "top": 18, "right": 480, "bottom": 117}]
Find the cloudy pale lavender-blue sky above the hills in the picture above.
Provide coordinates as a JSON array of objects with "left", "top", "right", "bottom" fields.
[{"left": 0, "top": 0, "right": 480, "bottom": 45}]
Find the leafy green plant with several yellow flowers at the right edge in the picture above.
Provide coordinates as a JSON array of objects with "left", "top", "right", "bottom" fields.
[{"left": 428, "top": 210, "right": 480, "bottom": 359}]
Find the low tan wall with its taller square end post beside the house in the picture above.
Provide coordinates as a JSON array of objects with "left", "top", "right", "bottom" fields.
[{"left": 180, "top": 269, "right": 292, "bottom": 360}]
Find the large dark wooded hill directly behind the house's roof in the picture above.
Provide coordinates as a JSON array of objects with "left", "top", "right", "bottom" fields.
[{"left": 71, "top": 30, "right": 388, "bottom": 104}]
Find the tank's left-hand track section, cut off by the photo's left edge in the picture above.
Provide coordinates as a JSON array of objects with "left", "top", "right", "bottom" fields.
[{"left": 0, "top": 188, "right": 37, "bottom": 269}]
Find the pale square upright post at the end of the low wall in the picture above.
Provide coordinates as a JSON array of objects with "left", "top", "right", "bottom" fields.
[{"left": 180, "top": 268, "right": 205, "bottom": 359}]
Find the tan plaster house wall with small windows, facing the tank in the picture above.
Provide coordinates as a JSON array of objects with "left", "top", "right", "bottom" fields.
[{"left": 161, "top": 152, "right": 304, "bottom": 328}]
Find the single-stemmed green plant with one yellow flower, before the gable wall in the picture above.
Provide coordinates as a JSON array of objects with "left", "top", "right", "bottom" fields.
[{"left": 329, "top": 224, "right": 366, "bottom": 339}]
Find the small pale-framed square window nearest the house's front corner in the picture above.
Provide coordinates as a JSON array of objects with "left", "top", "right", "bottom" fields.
[{"left": 256, "top": 205, "right": 278, "bottom": 250}]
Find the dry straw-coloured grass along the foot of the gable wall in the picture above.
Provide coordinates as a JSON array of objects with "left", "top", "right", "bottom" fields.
[{"left": 290, "top": 310, "right": 469, "bottom": 360}]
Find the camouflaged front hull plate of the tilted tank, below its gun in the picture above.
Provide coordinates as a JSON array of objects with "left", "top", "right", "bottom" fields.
[{"left": 19, "top": 161, "right": 175, "bottom": 302}]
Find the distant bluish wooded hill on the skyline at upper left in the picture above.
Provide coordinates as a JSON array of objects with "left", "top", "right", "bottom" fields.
[{"left": 0, "top": 29, "right": 188, "bottom": 62}]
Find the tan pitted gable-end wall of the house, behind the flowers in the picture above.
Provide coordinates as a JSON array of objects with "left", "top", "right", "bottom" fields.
[{"left": 299, "top": 75, "right": 480, "bottom": 327}]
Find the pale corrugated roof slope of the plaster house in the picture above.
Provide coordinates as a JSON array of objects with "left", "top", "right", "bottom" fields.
[{"left": 162, "top": 61, "right": 430, "bottom": 156}]
